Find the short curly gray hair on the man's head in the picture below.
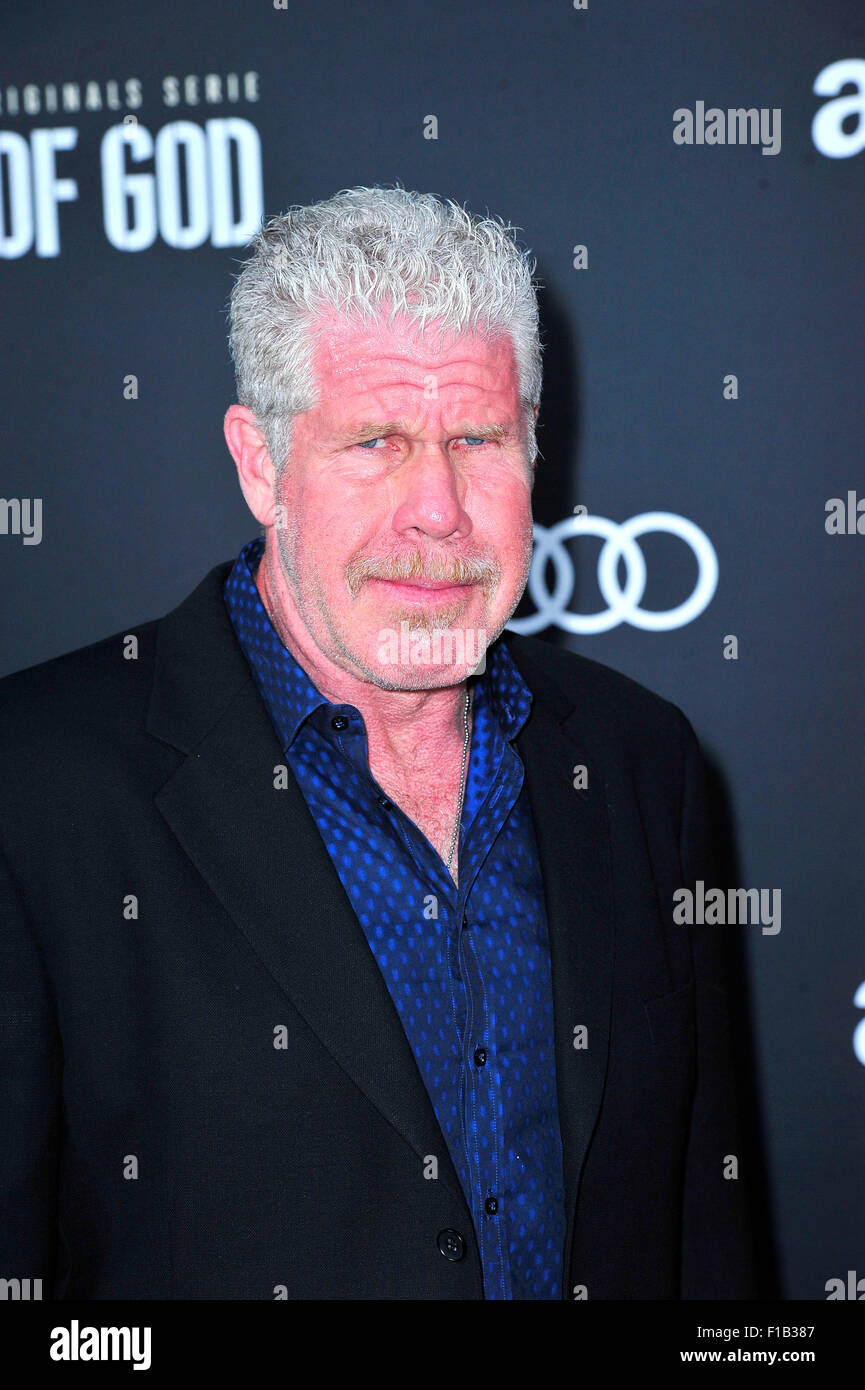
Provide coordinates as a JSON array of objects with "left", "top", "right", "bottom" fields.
[{"left": 228, "top": 185, "right": 542, "bottom": 474}]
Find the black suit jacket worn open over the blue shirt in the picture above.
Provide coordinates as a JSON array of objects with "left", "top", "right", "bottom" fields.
[{"left": 0, "top": 564, "right": 754, "bottom": 1300}]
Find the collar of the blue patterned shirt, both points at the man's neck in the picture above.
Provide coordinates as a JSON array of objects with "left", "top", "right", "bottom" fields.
[{"left": 223, "top": 537, "right": 531, "bottom": 751}]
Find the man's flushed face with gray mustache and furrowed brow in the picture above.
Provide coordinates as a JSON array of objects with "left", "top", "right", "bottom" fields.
[{"left": 268, "top": 316, "right": 533, "bottom": 689}]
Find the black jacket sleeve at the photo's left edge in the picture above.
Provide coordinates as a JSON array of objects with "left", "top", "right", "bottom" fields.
[{"left": 0, "top": 853, "right": 63, "bottom": 1298}]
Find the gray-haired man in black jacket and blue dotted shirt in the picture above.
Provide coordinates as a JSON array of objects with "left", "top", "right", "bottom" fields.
[{"left": 0, "top": 188, "right": 751, "bottom": 1300}]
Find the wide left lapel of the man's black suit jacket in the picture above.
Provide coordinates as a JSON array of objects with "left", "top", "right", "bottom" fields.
[{"left": 147, "top": 564, "right": 470, "bottom": 1206}]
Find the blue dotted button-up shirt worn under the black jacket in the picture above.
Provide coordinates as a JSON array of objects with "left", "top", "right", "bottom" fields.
[{"left": 224, "top": 538, "right": 565, "bottom": 1300}]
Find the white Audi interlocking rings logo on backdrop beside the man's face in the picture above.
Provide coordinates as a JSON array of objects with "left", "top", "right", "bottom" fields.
[{"left": 508, "top": 512, "right": 718, "bottom": 634}]
